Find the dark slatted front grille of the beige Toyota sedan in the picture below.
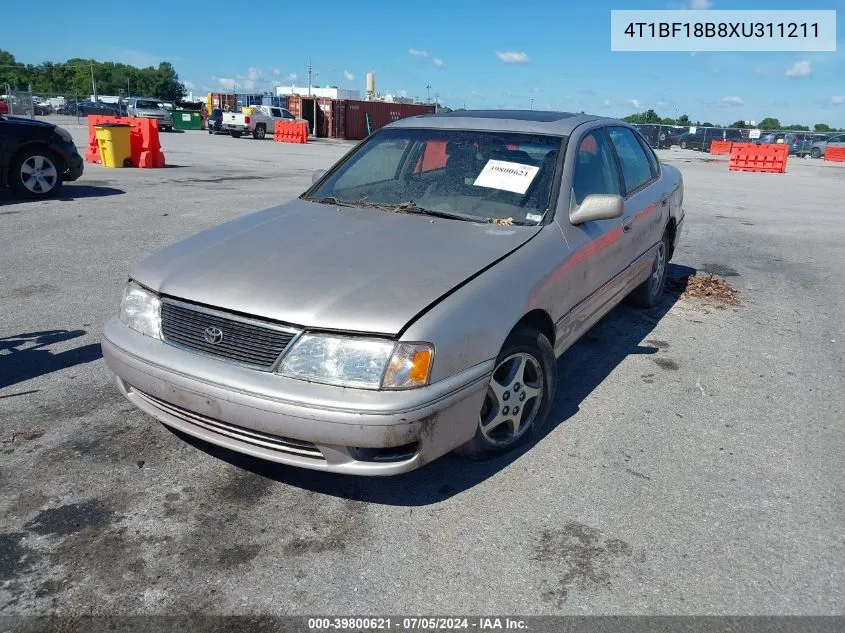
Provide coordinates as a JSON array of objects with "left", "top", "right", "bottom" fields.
[{"left": 161, "top": 300, "right": 298, "bottom": 371}]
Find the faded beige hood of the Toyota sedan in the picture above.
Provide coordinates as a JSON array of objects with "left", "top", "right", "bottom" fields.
[{"left": 131, "top": 200, "right": 541, "bottom": 335}]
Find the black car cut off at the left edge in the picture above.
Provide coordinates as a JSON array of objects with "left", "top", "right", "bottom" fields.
[{"left": 0, "top": 116, "right": 83, "bottom": 198}]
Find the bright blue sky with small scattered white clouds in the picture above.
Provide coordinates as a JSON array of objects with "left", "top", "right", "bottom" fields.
[{"left": 6, "top": 0, "right": 845, "bottom": 127}]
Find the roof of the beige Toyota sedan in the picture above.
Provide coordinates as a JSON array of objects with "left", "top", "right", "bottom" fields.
[{"left": 387, "top": 110, "right": 608, "bottom": 136}]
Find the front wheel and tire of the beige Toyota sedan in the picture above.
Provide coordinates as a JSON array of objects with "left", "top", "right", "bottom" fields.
[{"left": 455, "top": 326, "right": 557, "bottom": 461}]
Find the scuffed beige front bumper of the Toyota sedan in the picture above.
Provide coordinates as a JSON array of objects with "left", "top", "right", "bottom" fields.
[{"left": 102, "top": 318, "right": 493, "bottom": 475}]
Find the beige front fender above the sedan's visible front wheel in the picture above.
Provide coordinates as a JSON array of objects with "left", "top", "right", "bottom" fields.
[{"left": 401, "top": 223, "right": 569, "bottom": 382}]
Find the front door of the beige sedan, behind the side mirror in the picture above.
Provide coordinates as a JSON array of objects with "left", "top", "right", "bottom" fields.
[{"left": 552, "top": 127, "right": 626, "bottom": 351}]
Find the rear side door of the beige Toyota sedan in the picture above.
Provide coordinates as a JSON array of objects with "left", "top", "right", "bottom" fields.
[{"left": 607, "top": 126, "right": 672, "bottom": 286}]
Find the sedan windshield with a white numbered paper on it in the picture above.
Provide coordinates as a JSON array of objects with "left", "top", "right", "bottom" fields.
[{"left": 306, "top": 128, "right": 565, "bottom": 225}]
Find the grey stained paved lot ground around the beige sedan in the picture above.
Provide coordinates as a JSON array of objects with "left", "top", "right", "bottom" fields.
[{"left": 0, "top": 126, "right": 845, "bottom": 615}]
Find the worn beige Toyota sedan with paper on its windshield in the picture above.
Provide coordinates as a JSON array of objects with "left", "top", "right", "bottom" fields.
[{"left": 102, "top": 111, "right": 684, "bottom": 475}]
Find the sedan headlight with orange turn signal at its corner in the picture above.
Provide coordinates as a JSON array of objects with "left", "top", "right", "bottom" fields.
[{"left": 278, "top": 334, "right": 434, "bottom": 389}]
